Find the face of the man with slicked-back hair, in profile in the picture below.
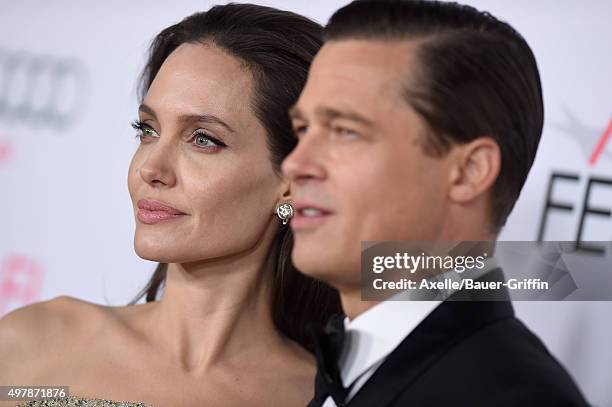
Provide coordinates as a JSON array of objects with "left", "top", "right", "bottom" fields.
[{"left": 283, "top": 40, "right": 449, "bottom": 287}]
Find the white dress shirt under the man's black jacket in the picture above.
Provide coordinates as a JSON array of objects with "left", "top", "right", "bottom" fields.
[{"left": 323, "top": 258, "right": 497, "bottom": 407}]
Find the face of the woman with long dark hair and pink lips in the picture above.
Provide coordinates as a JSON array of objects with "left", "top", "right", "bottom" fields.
[{"left": 128, "top": 44, "right": 287, "bottom": 263}]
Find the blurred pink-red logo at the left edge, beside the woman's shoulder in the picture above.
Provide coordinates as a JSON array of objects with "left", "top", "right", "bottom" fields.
[{"left": 0, "top": 254, "right": 44, "bottom": 315}]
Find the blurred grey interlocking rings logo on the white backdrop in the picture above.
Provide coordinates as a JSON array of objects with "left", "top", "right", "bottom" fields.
[{"left": 0, "top": 49, "right": 88, "bottom": 129}]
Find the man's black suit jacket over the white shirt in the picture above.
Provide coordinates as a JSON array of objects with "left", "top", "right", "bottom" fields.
[{"left": 317, "top": 270, "right": 588, "bottom": 407}]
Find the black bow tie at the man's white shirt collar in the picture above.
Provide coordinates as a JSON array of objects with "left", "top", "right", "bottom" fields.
[{"left": 308, "top": 315, "right": 348, "bottom": 407}]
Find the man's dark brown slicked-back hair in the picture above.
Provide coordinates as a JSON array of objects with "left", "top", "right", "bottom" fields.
[{"left": 325, "top": 0, "right": 544, "bottom": 232}]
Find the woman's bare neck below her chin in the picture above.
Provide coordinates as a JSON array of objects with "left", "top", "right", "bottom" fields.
[{"left": 148, "top": 223, "right": 282, "bottom": 376}]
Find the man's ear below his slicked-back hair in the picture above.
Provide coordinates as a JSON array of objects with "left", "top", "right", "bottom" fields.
[{"left": 449, "top": 137, "right": 501, "bottom": 203}]
